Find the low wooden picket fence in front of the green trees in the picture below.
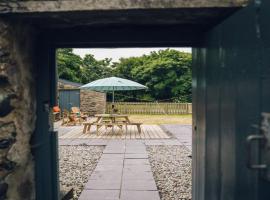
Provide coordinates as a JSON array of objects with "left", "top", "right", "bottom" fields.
[{"left": 106, "top": 102, "right": 192, "bottom": 115}]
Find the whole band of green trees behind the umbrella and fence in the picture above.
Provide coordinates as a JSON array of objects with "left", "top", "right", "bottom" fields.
[{"left": 57, "top": 49, "right": 192, "bottom": 102}]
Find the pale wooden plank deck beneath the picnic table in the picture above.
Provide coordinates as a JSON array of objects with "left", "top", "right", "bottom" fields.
[{"left": 60, "top": 125, "right": 170, "bottom": 139}]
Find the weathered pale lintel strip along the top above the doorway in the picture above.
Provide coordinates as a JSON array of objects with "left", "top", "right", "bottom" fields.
[{"left": 0, "top": 0, "right": 250, "bottom": 13}]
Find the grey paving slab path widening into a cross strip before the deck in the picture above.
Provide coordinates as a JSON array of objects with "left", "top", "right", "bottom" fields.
[{"left": 59, "top": 125, "right": 192, "bottom": 200}]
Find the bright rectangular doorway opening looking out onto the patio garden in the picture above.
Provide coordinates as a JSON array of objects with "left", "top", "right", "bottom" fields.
[{"left": 53, "top": 47, "right": 192, "bottom": 200}]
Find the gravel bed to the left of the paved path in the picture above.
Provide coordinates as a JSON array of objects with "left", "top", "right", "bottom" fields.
[{"left": 59, "top": 146, "right": 104, "bottom": 199}]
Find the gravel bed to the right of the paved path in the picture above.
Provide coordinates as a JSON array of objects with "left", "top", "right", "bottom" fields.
[{"left": 147, "top": 146, "right": 191, "bottom": 200}]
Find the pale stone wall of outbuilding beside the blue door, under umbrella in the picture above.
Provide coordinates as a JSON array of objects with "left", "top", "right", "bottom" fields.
[{"left": 80, "top": 90, "right": 106, "bottom": 115}]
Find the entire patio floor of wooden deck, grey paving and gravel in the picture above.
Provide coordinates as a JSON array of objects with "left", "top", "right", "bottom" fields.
[{"left": 57, "top": 118, "right": 191, "bottom": 200}]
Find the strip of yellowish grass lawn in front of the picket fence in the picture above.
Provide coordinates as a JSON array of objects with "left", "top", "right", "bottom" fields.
[{"left": 129, "top": 114, "right": 192, "bottom": 125}]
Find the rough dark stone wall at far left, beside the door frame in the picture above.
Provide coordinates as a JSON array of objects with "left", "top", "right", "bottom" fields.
[{"left": 0, "top": 19, "right": 36, "bottom": 200}]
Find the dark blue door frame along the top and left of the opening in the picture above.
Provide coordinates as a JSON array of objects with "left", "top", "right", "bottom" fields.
[{"left": 34, "top": 6, "right": 249, "bottom": 200}]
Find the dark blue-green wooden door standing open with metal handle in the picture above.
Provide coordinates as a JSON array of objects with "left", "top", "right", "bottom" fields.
[{"left": 193, "top": 0, "right": 270, "bottom": 200}]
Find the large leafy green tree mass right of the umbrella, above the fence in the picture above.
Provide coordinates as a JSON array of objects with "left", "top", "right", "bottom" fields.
[{"left": 112, "top": 49, "right": 191, "bottom": 102}]
